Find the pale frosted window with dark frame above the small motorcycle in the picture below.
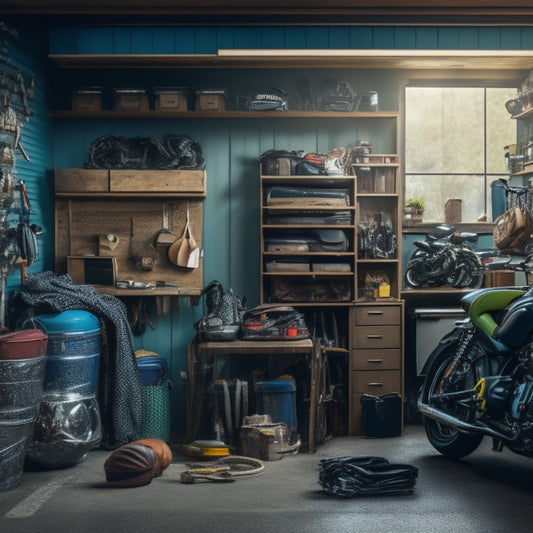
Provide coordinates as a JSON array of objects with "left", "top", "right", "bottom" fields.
[{"left": 405, "top": 86, "right": 516, "bottom": 222}]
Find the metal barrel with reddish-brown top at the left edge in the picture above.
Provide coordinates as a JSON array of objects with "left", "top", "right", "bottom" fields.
[{"left": 0, "top": 329, "right": 47, "bottom": 492}]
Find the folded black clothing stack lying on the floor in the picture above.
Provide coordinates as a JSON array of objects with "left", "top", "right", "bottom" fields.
[{"left": 319, "top": 456, "right": 418, "bottom": 498}]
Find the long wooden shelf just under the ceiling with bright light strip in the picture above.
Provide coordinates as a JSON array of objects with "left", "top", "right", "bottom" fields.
[{"left": 48, "top": 50, "right": 533, "bottom": 70}]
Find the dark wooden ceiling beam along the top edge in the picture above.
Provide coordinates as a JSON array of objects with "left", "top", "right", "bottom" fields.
[{"left": 0, "top": 0, "right": 533, "bottom": 25}]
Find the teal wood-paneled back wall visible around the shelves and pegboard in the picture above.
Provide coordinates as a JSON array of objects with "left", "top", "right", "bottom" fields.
[{"left": 40, "top": 22, "right": 533, "bottom": 431}]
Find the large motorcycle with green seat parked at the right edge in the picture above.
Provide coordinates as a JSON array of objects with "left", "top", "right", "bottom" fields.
[{"left": 418, "top": 255, "right": 533, "bottom": 459}]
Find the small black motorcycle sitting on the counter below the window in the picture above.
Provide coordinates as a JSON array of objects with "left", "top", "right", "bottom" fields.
[{"left": 405, "top": 224, "right": 484, "bottom": 289}]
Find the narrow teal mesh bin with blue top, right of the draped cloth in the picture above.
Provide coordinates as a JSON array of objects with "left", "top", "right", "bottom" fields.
[{"left": 135, "top": 350, "right": 170, "bottom": 442}]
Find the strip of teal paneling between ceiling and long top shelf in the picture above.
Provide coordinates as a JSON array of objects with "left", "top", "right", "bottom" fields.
[{"left": 50, "top": 25, "right": 533, "bottom": 54}]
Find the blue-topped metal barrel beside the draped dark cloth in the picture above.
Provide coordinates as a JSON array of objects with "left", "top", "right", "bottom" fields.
[{"left": 26, "top": 310, "right": 102, "bottom": 469}]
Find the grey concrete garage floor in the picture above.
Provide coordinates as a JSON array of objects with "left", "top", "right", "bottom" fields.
[{"left": 0, "top": 425, "right": 533, "bottom": 533}]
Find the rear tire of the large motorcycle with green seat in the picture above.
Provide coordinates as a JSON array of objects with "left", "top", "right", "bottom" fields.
[{"left": 421, "top": 343, "right": 483, "bottom": 459}]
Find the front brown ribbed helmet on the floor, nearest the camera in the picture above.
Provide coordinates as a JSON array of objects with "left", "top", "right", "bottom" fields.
[{"left": 104, "top": 443, "right": 160, "bottom": 487}]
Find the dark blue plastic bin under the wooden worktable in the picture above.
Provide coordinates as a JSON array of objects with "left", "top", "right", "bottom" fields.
[{"left": 255, "top": 379, "right": 297, "bottom": 443}]
